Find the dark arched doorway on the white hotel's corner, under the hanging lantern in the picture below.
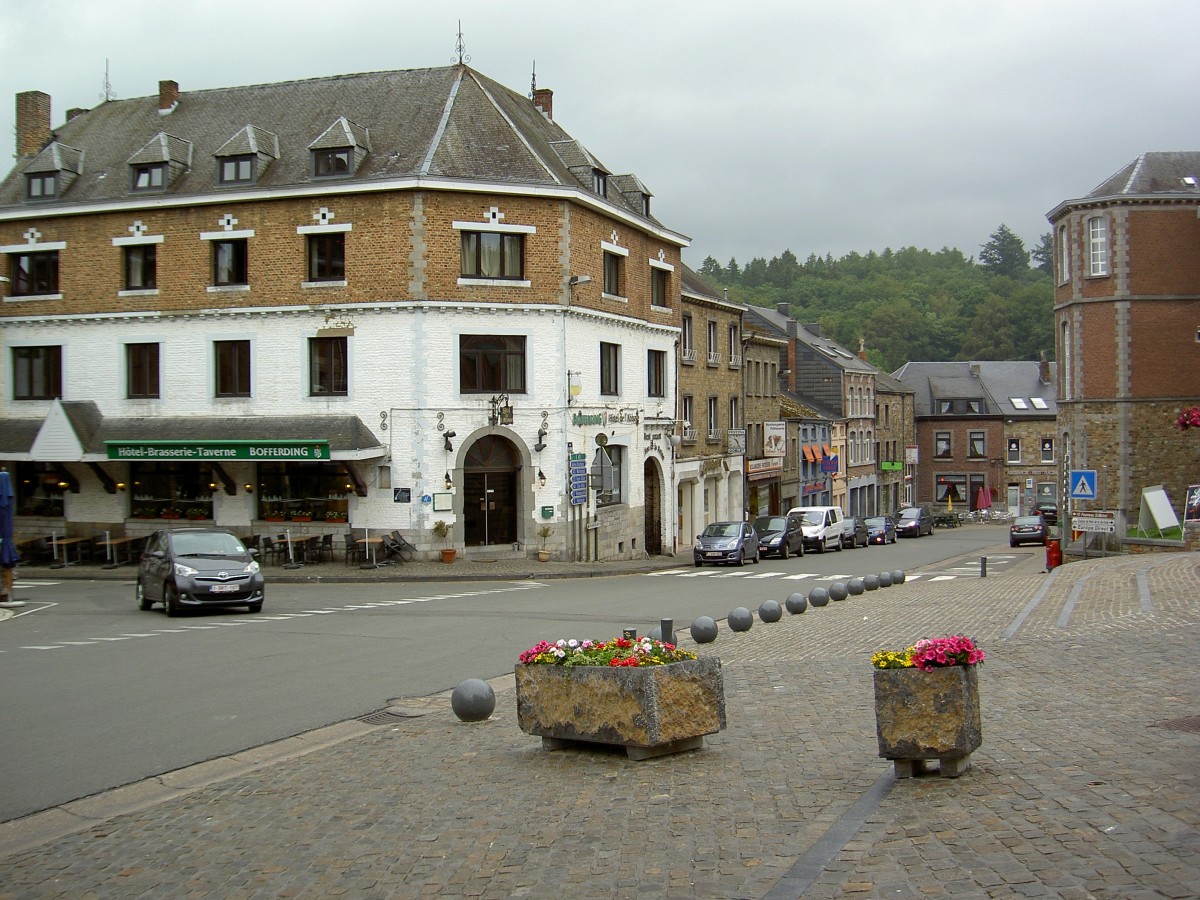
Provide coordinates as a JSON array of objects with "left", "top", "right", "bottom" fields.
[{"left": 462, "top": 434, "right": 521, "bottom": 547}]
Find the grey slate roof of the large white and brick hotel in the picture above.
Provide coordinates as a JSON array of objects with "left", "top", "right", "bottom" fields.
[{"left": 0, "top": 65, "right": 676, "bottom": 234}]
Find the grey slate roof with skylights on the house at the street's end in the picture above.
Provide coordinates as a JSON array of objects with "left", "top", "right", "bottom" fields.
[{"left": 892, "top": 360, "right": 1058, "bottom": 419}]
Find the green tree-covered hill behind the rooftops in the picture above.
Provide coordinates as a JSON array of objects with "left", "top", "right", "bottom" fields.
[{"left": 700, "top": 224, "right": 1054, "bottom": 372}]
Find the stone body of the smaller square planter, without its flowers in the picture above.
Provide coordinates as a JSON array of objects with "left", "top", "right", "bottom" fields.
[{"left": 875, "top": 666, "right": 983, "bottom": 778}]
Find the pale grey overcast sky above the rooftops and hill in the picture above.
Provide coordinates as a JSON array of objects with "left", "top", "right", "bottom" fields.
[{"left": 0, "top": 0, "right": 1200, "bottom": 268}]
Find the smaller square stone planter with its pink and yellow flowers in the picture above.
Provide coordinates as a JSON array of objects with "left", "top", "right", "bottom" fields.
[{"left": 871, "top": 635, "right": 984, "bottom": 778}]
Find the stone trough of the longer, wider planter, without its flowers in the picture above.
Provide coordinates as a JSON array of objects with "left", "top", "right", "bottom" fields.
[{"left": 516, "top": 656, "right": 725, "bottom": 760}]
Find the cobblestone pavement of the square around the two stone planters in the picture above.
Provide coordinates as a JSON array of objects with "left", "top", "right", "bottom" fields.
[{"left": 0, "top": 553, "right": 1200, "bottom": 898}]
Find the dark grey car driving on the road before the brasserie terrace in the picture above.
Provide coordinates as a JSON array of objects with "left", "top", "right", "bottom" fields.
[{"left": 136, "top": 528, "right": 264, "bottom": 616}]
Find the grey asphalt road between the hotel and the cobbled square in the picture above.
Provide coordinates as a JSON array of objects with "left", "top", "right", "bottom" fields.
[{"left": 0, "top": 526, "right": 1017, "bottom": 821}]
